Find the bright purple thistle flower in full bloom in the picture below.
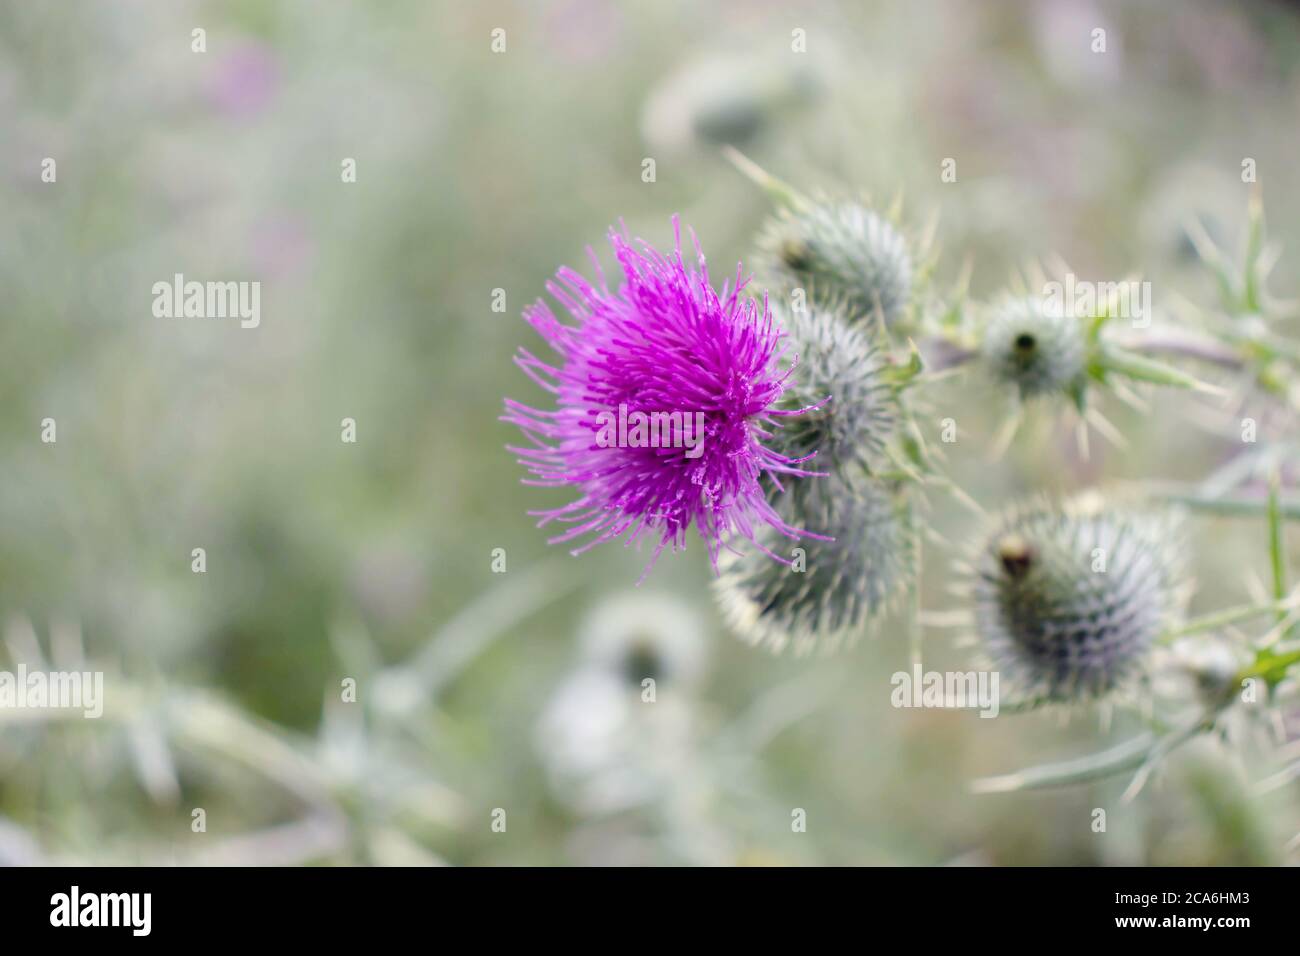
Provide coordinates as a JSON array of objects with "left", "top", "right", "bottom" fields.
[{"left": 502, "top": 216, "right": 820, "bottom": 574}]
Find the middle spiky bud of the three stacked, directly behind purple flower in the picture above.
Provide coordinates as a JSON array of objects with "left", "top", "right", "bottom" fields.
[{"left": 772, "top": 307, "right": 898, "bottom": 471}]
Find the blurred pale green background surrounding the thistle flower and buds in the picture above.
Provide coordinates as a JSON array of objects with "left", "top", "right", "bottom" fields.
[{"left": 0, "top": 0, "right": 1300, "bottom": 864}]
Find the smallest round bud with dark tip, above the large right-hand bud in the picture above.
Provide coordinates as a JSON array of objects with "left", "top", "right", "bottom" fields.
[{"left": 982, "top": 297, "right": 1084, "bottom": 398}]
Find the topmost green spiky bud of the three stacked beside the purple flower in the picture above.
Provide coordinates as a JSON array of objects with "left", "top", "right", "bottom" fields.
[{"left": 759, "top": 202, "right": 913, "bottom": 325}]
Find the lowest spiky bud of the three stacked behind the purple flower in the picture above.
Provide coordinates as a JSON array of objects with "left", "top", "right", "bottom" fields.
[{"left": 714, "top": 470, "right": 913, "bottom": 654}]
